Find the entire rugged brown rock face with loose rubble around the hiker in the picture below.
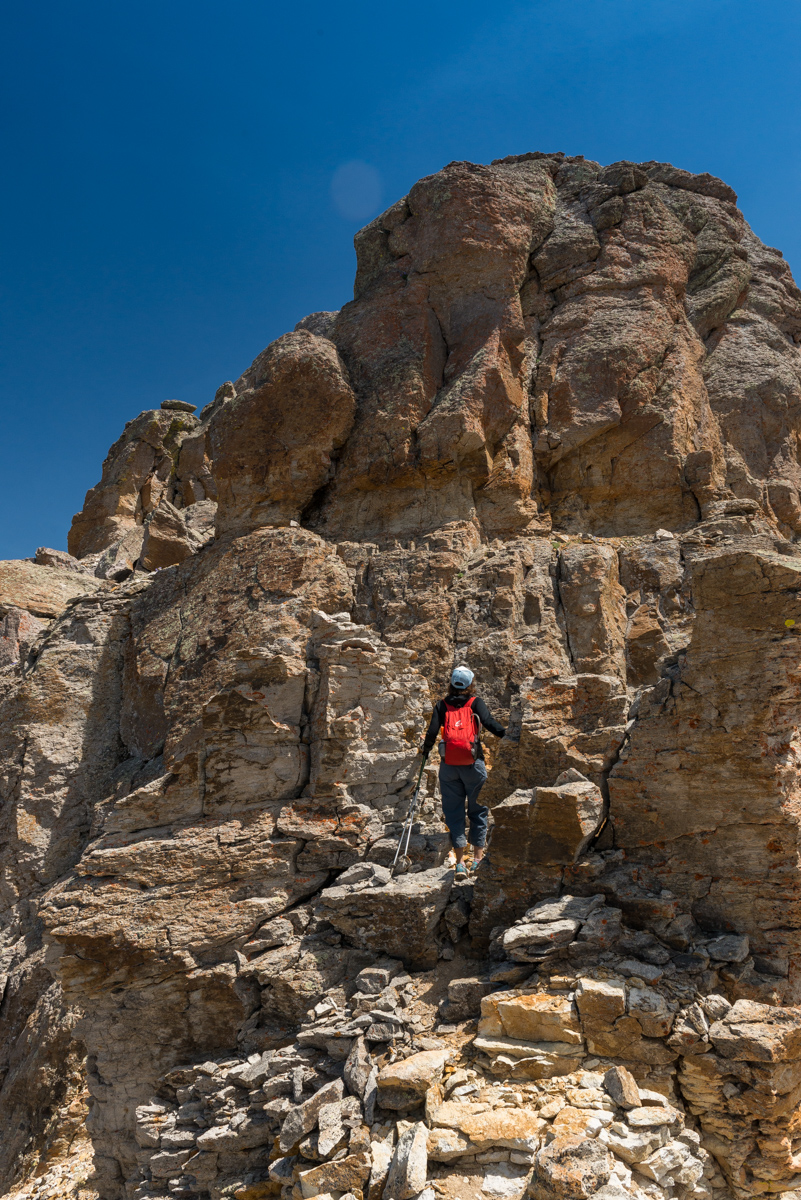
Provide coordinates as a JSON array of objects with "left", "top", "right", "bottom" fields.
[{"left": 0, "top": 154, "right": 801, "bottom": 1200}]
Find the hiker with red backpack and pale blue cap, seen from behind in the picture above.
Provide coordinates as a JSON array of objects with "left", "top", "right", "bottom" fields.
[{"left": 423, "top": 666, "right": 506, "bottom": 878}]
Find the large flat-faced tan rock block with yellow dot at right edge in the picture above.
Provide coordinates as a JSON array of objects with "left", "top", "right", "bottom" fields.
[{"left": 609, "top": 550, "right": 801, "bottom": 988}]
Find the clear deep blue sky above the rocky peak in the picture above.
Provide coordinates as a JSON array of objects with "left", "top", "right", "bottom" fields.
[{"left": 0, "top": 0, "right": 801, "bottom": 558}]
